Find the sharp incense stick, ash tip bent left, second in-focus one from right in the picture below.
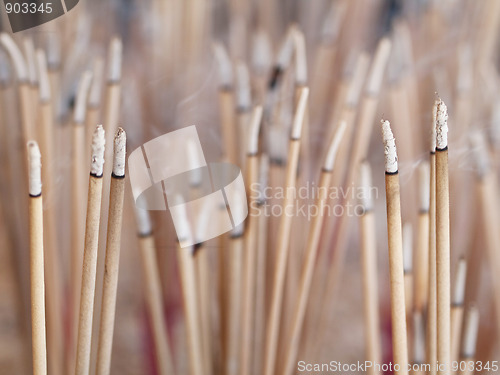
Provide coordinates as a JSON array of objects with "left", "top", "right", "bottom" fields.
[{"left": 382, "top": 121, "right": 408, "bottom": 375}]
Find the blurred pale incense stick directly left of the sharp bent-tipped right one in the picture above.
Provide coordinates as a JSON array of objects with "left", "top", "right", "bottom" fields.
[{"left": 360, "top": 163, "right": 382, "bottom": 375}]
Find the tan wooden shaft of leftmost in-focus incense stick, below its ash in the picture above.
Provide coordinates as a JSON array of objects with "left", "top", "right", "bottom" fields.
[{"left": 29, "top": 196, "right": 47, "bottom": 375}]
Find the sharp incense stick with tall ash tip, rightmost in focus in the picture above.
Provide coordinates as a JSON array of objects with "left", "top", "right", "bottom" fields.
[{"left": 436, "top": 101, "right": 451, "bottom": 374}]
